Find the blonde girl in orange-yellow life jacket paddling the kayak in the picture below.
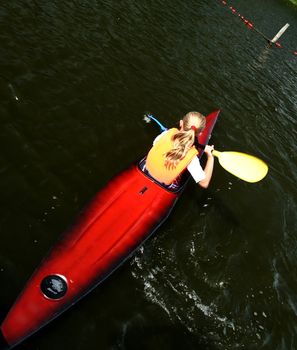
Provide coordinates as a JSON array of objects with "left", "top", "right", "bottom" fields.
[{"left": 145, "top": 112, "right": 214, "bottom": 188}]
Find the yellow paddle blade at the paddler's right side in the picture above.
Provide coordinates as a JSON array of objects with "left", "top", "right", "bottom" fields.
[{"left": 212, "top": 150, "right": 268, "bottom": 183}]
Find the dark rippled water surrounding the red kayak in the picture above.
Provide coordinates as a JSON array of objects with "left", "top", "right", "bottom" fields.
[{"left": 0, "top": 0, "right": 297, "bottom": 350}]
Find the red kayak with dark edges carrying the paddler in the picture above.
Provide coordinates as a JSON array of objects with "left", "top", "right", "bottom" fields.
[{"left": 0, "top": 111, "right": 219, "bottom": 349}]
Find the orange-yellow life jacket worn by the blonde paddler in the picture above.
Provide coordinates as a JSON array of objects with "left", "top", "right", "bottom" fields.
[{"left": 146, "top": 128, "right": 198, "bottom": 185}]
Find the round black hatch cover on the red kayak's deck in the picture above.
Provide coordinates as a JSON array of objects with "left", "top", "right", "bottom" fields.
[{"left": 40, "top": 275, "right": 67, "bottom": 300}]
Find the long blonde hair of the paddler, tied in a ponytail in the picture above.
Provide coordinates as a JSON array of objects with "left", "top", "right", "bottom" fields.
[{"left": 164, "top": 112, "right": 206, "bottom": 169}]
